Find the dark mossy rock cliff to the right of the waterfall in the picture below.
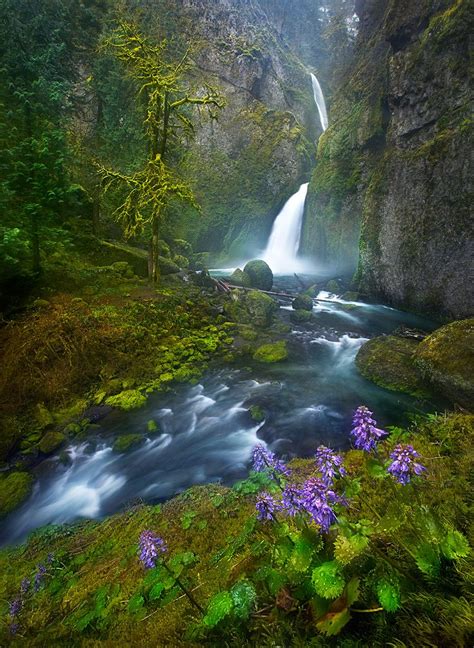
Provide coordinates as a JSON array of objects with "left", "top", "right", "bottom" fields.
[{"left": 304, "top": 0, "right": 474, "bottom": 318}]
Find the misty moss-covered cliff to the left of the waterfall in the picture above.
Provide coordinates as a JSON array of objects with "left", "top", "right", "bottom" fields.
[{"left": 140, "top": 0, "right": 318, "bottom": 258}]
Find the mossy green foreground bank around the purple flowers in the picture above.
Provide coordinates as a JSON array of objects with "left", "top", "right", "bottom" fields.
[{"left": 0, "top": 415, "right": 474, "bottom": 648}]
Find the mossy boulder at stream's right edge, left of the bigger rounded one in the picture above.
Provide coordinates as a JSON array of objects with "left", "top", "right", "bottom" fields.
[{"left": 356, "top": 335, "right": 429, "bottom": 397}]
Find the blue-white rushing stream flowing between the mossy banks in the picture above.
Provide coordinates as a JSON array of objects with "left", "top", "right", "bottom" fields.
[{"left": 0, "top": 280, "right": 436, "bottom": 544}]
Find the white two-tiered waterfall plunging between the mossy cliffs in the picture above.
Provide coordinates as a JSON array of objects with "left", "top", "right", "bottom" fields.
[{"left": 262, "top": 74, "right": 328, "bottom": 274}]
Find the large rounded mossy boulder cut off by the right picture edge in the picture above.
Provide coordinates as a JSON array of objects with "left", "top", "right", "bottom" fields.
[{"left": 414, "top": 319, "right": 474, "bottom": 411}]
